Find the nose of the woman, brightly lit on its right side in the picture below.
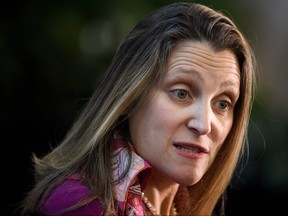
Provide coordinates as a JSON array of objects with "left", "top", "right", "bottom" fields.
[{"left": 187, "top": 101, "right": 213, "bottom": 135}]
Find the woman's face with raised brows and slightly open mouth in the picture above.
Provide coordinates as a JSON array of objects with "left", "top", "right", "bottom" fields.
[{"left": 129, "top": 41, "right": 240, "bottom": 185}]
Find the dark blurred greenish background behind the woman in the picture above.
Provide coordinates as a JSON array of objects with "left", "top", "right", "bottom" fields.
[{"left": 0, "top": 0, "right": 288, "bottom": 215}]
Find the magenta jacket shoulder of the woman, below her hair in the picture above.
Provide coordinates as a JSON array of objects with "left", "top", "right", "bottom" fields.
[{"left": 45, "top": 176, "right": 103, "bottom": 216}]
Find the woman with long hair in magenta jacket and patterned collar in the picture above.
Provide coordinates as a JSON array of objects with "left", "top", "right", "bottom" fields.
[{"left": 24, "top": 3, "right": 255, "bottom": 215}]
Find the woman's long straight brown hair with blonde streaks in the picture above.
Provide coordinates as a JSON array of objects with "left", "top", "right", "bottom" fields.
[{"left": 24, "top": 3, "right": 255, "bottom": 215}]
